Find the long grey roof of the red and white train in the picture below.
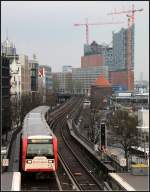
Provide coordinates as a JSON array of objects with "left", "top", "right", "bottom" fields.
[{"left": 22, "top": 106, "right": 54, "bottom": 137}]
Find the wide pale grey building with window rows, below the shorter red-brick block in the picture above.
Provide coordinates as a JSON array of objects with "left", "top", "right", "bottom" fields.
[{"left": 72, "top": 66, "right": 108, "bottom": 95}]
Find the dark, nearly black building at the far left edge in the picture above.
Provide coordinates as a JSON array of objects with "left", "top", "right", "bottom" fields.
[{"left": 0, "top": 54, "right": 11, "bottom": 135}]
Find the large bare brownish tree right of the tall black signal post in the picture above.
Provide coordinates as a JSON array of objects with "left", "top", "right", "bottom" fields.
[{"left": 109, "top": 110, "right": 138, "bottom": 169}]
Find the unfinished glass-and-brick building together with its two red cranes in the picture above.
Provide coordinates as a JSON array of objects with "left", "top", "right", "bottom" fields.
[{"left": 74, "top": 5, "right": 143, "bottom": 91}]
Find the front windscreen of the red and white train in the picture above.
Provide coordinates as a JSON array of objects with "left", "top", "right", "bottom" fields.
[{"left": 27, "top": 143, "right": 54, "bottom": 158}]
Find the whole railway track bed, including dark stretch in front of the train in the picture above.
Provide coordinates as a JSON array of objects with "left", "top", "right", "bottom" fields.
[{"left": 10, "top": 97, "right": 108, "bottom": 191}]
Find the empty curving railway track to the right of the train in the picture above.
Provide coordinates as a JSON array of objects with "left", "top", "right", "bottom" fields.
[{"left": 51, "top": 99, "right": 103, "bottom": 190}]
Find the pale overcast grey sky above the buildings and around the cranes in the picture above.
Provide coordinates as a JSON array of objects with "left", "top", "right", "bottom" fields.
[{"left": 1, "top": 1, "right": 149, "bottom": 80}]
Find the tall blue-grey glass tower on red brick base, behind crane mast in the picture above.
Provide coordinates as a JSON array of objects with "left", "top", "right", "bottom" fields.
[{"left": 109, "top": 25, "right": 134, "bottom": 90}]
